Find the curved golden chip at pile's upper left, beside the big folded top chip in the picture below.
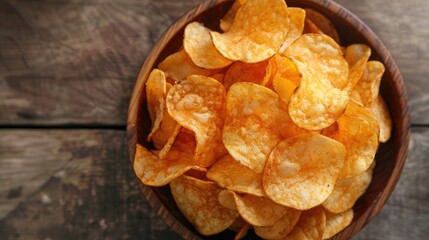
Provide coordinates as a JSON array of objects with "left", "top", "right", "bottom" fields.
[{"left": 183, "top": 22, "right": 232, "bottom": 69}]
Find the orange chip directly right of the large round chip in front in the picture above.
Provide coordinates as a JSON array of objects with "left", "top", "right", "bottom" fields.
[{"left": 330, "top": 106, "right": 378, "bottom": 179}]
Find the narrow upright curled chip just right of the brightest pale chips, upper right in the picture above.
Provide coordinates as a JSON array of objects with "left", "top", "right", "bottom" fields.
[{"left": 344, "top": 44, "right": 371, "bottom": 91}]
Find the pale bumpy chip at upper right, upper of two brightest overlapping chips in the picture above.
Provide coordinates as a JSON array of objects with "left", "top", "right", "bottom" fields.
[{"left": 283, "top": 33, "right": 349, "bottom": 89}]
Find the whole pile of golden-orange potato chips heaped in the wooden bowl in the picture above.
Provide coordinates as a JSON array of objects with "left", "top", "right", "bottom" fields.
[{"left": 134, "top": 0, "right": 392, "bottom": 239}]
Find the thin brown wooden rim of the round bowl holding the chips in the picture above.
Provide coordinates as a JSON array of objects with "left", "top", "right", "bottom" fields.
[{"left": 127, "top": 0, "right": 411, "bottom": 239}]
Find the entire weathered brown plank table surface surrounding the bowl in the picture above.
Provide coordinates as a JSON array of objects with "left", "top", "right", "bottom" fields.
[{"left": 0, "top": 0, "right": 429, "bottom": 239}]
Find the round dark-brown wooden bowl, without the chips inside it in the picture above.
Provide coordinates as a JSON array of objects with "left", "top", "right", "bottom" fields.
[{"left": 127, "top": 0, "right": 410, "bottom": 239}]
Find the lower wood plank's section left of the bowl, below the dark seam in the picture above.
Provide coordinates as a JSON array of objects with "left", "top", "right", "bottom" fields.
[{"left": 0, "top": 130, "right": 178, "bottom": 240}]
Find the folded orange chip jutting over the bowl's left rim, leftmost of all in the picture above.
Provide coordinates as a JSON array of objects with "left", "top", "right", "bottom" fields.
[{"left": 134, "top": 131, "right": 201, "bottom": 187}]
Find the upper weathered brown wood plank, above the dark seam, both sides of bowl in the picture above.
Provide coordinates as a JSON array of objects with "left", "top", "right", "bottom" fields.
[{"left": 0, "top": 0, "right": 429, "bottom": 126}]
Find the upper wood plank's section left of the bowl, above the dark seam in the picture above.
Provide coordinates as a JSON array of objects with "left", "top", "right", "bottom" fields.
[{"left": 0, "top": 0, "right": 201, "bottom": 126}]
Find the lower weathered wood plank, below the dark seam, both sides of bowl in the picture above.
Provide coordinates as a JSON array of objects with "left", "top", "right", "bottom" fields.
[{"left": 0, "top": 128, "right": 429, "bottom": 240}]
